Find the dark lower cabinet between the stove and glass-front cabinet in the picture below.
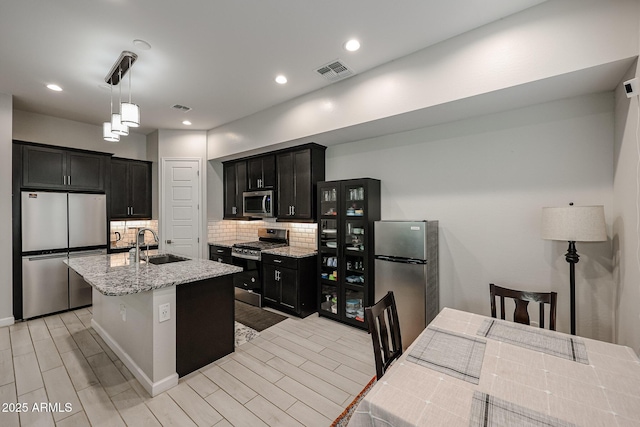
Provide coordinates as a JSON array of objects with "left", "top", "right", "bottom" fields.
[{"left": 262, "top": 254, "right": 317, "bottom": 317}]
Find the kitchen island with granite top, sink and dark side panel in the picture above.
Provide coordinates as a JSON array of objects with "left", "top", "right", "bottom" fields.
[{"left": 65, "top": 253, "right": 242, "bottom": 396}]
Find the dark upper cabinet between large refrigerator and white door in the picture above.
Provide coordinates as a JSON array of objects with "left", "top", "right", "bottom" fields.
[{"left": 109, "top": 158, "right": 152, "bottom": 220}]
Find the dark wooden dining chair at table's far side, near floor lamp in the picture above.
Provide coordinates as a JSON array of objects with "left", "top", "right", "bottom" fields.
[{"left": 489, "top": 283, "right": 558, "bottom": 331}]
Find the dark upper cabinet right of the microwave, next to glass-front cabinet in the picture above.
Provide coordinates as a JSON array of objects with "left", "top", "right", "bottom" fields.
[{"left": 276, "top": 144, "right": 326, "bottom": 221}]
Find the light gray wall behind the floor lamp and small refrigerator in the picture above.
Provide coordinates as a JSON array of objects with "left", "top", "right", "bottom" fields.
[{"left": 326, "top": 92, "right": 614, "bottom": 341}]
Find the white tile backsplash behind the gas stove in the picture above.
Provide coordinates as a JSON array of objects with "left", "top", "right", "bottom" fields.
[{"left": 207, "top": 220, "right": 318, "bottom": 249}]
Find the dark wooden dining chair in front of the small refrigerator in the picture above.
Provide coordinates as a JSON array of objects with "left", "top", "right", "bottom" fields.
[{"left": 364, "top": 291, "right": 402, "bottom": 380}]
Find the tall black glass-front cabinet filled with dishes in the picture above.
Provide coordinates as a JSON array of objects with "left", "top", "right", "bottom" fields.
[{"left": 317, "top": 178, "right": 380, "bottom": 329}]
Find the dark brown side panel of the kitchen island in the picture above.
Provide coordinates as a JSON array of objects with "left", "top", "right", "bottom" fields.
[{"left": 176, "top": 274, "right": 235, "bottom": 377}]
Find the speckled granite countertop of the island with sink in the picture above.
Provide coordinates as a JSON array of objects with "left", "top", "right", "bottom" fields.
[{"left": 64, "top": 251, "right": 242, "bottom": 296}]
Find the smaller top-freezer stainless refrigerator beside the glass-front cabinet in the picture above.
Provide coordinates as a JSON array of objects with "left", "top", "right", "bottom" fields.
[{"left": 374, "top": 221, "right": 440, "bottom": 349}]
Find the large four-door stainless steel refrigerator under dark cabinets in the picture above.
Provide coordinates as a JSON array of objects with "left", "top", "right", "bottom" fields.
[{"left": 21, "top": 191, "right": 107, "bottom": 319}]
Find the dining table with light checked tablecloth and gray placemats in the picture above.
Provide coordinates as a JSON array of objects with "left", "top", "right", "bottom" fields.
[{"left": 348, "top": 308, "right": 640, "bottom": 427}]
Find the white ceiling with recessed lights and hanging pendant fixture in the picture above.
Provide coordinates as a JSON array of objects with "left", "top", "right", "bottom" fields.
[{"left": 0, "top": 0, "right": 544, "bottom": 134}]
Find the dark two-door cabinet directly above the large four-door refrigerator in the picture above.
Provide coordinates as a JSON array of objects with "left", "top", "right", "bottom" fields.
[{"left": 22, "top": 145, "right": 110, "bottom": 191}]
